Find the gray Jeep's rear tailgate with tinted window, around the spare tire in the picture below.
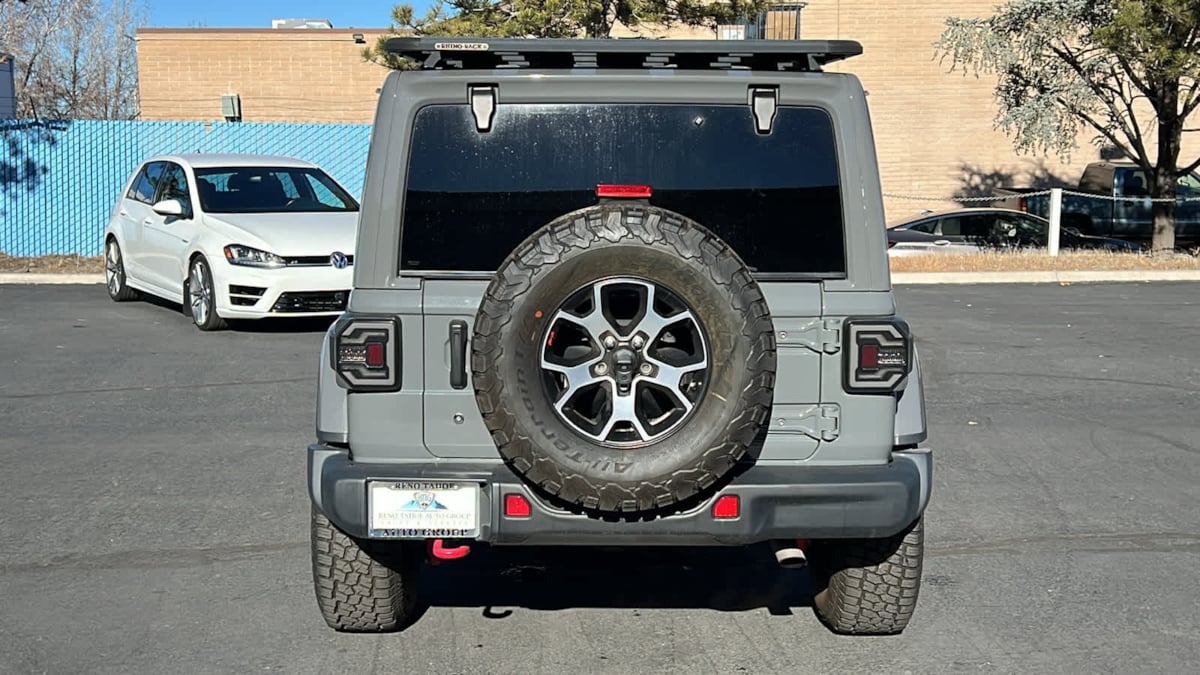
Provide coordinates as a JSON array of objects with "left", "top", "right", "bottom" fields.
[{"left": 410, "top": 97, "right": 846, "bottom": 459}]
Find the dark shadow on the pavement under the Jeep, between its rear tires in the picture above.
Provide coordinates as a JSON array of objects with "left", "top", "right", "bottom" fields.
[{"left": 420, "top": 544, "right": 811, "bottom": 619}]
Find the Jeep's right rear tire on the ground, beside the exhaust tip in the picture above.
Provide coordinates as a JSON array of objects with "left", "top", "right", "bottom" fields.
[{"left": 811, "top": 518, "right": 925, "bottom": 635}]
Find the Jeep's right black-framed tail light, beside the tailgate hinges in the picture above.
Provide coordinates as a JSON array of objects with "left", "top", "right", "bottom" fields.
[{"left": 844, "top": 318, "right": 912, "bottom": 394}]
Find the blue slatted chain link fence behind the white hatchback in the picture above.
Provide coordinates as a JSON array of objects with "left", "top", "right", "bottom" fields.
[{"left": 0, "top": 120, "right": 371, "bottom": 256}]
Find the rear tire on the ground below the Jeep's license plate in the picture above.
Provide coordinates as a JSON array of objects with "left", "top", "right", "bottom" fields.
[{"left": 311, "top": 507, "right": 422, "bottom": 633}]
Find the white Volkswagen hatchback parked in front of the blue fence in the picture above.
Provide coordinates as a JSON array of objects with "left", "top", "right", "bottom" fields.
[{"left": 104, "top": 154, "right": 359, "bottom": 330}]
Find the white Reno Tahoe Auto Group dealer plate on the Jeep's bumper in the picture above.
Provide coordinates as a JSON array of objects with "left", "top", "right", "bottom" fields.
[{"left": 367, "top": 480, "right": 480, "bottom": 539}]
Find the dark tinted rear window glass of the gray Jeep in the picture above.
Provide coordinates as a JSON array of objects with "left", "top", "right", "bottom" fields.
[{"left": 401, "top": 104, "right": 846, "bottom": 276}]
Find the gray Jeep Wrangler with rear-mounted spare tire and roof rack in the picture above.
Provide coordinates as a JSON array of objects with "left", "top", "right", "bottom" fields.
[{"left": 308, "top": 37, "right": 932, "bottom": 634}]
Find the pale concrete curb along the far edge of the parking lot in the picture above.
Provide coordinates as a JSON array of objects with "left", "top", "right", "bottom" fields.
[{"left": 0, "top": 269, "right": 1200, "bottom": 286}]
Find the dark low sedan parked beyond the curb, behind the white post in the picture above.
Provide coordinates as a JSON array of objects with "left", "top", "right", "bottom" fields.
[{"left": 888, "top": 208, "right": 1139, "bottom": 256}]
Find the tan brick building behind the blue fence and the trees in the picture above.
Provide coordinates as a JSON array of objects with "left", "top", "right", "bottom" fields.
[{"left": 138, "top": 0, "right": 1200, "bottom": 219}]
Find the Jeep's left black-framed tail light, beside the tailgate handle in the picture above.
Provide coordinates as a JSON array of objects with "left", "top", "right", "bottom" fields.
[{"left": 330, "top": 316, "right": 401, "bottom": 392}]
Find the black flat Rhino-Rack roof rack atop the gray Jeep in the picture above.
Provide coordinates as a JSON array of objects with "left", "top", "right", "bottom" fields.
[{"left": 384, "top": 37, "right": 863, "bottom": 71}]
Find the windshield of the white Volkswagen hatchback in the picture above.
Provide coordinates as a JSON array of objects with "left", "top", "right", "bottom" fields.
[{"left": 196, "top": 167, "right": 359, "bottom": 214}]
